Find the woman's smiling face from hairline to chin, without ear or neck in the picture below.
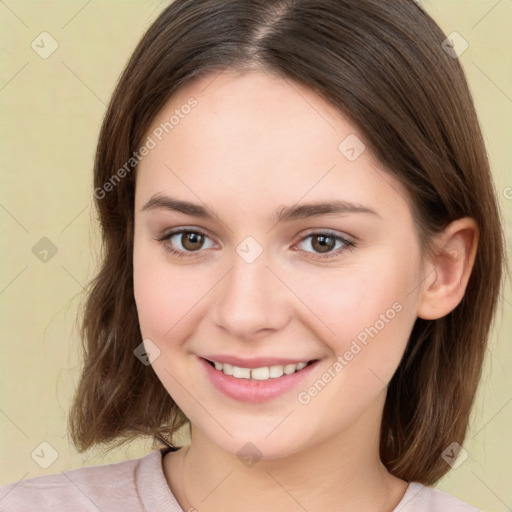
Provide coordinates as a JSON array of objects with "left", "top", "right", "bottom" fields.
[{"left": 133, "top": 71, "right": 422, "bottom": 458}]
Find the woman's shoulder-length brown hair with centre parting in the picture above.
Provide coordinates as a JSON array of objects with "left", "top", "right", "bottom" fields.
[{"left": 69, "top": 0, "right": 504, "bottom": 485}]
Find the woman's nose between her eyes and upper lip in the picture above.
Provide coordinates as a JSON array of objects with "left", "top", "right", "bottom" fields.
[{"left": 212, "top": 248, "right": 292, "bottom": 340}]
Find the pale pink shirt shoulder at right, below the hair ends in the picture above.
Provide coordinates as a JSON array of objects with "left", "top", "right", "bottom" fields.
[{"left": 393, "top": 482, "right": 480, "bottom": 512}]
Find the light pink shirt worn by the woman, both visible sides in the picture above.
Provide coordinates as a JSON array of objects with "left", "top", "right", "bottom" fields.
[{"left": 0, "top": 448, "right": 479, "bottom": 512}]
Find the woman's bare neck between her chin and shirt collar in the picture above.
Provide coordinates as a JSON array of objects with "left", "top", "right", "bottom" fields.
[{"left": 164, "top": 390, "right": 407, "bottom": 512}]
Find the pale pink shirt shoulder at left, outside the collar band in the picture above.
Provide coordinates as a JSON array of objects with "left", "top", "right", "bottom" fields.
[{"left": 0, "top": 450, "right": 161, "bottom": 512}]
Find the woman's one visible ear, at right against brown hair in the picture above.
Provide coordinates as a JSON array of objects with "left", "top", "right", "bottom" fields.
[{"left": 417, "top": 217, "right": 479, "bottom": 320}]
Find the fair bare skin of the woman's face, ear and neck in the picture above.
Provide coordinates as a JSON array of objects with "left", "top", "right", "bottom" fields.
[{"left": 133, "top": 71, "right": 478, "bottom": 512}]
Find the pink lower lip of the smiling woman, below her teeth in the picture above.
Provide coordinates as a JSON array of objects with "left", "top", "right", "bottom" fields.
[{"left": 199, "top": 358, "right": 320, "bottom": 404}]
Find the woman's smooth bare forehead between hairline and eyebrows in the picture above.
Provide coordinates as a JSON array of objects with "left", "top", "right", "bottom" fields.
[{"left": 136, "top": 71, "right": 405, "bottom": 220}]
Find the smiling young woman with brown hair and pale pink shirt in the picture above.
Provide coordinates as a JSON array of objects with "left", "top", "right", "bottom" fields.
[{"left": 0, "top": 0, "right": 503, "bottom": 512}]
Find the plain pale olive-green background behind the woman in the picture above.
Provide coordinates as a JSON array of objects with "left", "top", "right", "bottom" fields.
[{"left": 0, "top": 0, "right": 512, "bottom": 511}]
